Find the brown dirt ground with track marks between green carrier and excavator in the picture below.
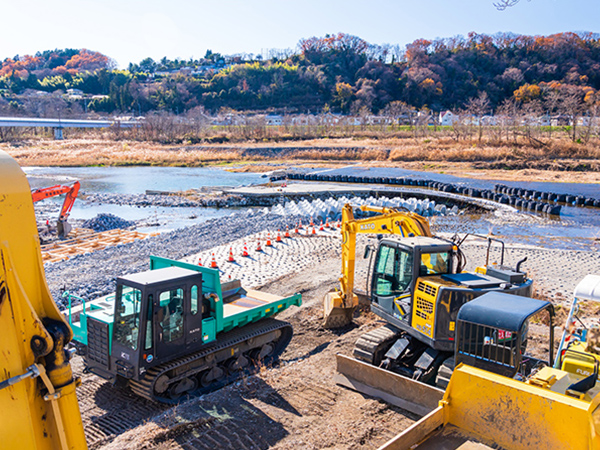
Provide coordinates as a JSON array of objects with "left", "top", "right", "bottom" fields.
[{"left": 84, "top": 253, "right": 418, "bottom": 449}]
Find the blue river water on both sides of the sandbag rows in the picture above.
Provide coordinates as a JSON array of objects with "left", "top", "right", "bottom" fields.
[{"left": 24, "top": 166, "right": 600, "bottom": 249}]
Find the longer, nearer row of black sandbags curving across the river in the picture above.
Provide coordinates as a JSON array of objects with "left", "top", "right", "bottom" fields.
[{"left": 287, "top": 172, "right": 561, "bottom": 215}]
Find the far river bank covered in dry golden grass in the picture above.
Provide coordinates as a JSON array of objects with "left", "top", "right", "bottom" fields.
[{"left": 0, "top": 138, "right": 600, "bottom": 183}]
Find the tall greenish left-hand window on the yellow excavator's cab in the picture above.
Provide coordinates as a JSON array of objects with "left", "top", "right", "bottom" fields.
[{"left": 374, "top": 245, "right": 413, "bottom": 297}]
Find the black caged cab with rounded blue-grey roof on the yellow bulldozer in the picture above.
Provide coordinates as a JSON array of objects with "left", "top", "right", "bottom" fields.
[{"left": 455, "top": 292, "right": 554, "bottom": 378}]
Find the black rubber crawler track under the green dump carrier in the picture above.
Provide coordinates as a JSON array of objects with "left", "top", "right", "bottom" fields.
[{"left": 129, "top": 319, "right": 293, "bottom": 404}]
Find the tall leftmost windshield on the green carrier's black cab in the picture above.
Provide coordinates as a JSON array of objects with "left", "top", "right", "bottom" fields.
[{"left": 115, "top": 285, "right": 142, "bottom": 350}]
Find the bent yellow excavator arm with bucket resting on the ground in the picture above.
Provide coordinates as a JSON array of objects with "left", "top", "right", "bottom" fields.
[{"left": 323, "top": 204, "right": 432, "bottom": 328}]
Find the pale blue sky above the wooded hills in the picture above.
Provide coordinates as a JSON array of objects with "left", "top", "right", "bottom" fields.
[{"left": 0, "top": 0, "right": 600, "bottom": 68}]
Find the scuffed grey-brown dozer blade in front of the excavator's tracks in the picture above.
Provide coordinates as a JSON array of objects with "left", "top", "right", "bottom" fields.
[{"left": 333, "top": 353, "right": 444, "bottom": 416}]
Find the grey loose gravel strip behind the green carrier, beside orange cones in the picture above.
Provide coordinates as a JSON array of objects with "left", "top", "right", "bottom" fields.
[{"left": 45, "top": 211, "right": 298, "bottom": 307}]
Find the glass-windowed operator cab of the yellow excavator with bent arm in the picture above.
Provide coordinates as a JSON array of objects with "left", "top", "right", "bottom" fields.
[{"left": 370, "top": 236, "right": 453, "bottom": 318}]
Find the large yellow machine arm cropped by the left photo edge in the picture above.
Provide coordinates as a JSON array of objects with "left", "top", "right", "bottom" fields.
[{"left": 0, "top": 151, "right": 86, "bottom": 449}]
